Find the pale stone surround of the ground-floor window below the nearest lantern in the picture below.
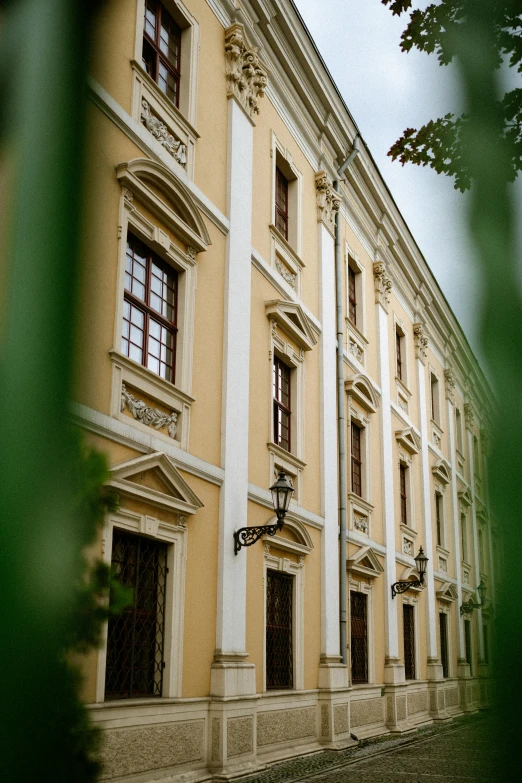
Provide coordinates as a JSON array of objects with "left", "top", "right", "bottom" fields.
[{"left": 263, "top": 544, "right": 305, "bottom": 695}]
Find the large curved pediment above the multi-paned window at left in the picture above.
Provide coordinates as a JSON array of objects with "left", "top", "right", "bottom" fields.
[{"left": 116, "top": 158, "right": 211, "bottom": 252}]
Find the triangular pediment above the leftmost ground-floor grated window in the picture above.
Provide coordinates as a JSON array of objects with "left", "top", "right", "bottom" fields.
[{"left": 108, "top": 452, "right": 203, "bottom": 514}]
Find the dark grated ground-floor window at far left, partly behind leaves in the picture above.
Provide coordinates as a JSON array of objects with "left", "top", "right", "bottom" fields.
[{"left": 105, "top": 529, "right": 167, "bottom": 699}]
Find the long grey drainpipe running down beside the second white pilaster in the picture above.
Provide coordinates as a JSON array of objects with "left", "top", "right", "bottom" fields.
[{"left": 333, "top": 136, "right": 359, "bottom": 665}]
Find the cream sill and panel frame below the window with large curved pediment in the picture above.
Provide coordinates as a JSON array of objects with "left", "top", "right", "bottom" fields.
[{"left": 109, "top": 349, "right": 195, "bottom": 451}]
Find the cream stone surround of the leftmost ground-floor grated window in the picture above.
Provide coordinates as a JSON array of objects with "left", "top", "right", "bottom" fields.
[{"left": 96, "top": 509, "right": 187, "bottom": 704}]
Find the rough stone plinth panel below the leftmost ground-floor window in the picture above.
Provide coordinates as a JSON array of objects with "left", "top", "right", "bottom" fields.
[{"left": 101, "top": 720, "right": 205, "bottom": 780}]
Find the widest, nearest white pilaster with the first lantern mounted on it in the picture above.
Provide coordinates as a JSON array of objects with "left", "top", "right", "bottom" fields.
[{"left": 213, "top": 98, "right": 255, "bottom": 695}]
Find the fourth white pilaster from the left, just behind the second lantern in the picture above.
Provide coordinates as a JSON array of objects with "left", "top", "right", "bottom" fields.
[{"left": 415, "top": 352, "right": 438, "bottom": 664}]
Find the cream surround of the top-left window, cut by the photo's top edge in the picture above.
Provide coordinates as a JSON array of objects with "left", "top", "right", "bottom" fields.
[{"left": 131, "top": 0, "right": 200, "bottom": 179}]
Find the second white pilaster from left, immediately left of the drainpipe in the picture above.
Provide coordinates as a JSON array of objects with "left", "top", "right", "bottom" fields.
[{"left": 317, "top": 222, "right": 340, "bottom": 672}]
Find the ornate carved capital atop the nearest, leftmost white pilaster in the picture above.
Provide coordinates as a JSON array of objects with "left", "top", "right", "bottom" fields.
[{"left": 225, "top": 24, "right": 268, "bottom": 119}]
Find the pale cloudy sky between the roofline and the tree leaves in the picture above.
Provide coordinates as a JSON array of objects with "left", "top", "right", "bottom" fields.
[{"left": 295, "top": 0, "right": 480, "bottom": 354}]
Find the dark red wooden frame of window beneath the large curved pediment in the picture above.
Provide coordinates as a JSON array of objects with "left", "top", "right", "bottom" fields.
[{"left": 121, "top": 231, "right": 178, "bottom": 385}]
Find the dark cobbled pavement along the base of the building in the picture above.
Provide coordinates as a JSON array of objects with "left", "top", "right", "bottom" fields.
[{"left": 236, "top": 714, "right": 498, "bottom": 783}]
